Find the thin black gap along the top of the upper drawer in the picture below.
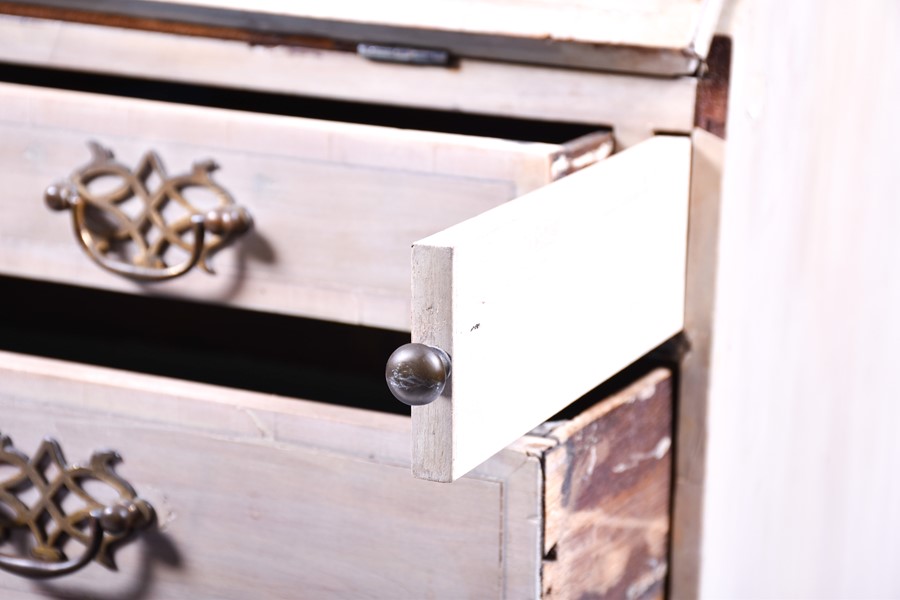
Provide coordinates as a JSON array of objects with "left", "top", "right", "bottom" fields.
[{"left": 0, "top": 63, "right": 603, "bottom": 144}]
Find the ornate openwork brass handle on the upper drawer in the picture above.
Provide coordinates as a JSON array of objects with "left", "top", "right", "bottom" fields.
[{"left": 44, "top": 142, "right": 253, "bottom": 281}]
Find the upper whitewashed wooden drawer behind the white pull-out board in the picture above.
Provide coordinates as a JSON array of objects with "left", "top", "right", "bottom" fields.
[{"left": 0, "top": 84, "right": 609, "bottom": 330}]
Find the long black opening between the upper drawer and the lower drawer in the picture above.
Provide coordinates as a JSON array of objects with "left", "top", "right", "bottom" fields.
[{"left": 0, "top": 277, "right": 679, "bottom": 420}]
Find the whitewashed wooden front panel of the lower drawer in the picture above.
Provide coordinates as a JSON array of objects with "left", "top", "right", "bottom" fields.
[{"left": 0, "top": 353, "right": 542, "bottom": 599}]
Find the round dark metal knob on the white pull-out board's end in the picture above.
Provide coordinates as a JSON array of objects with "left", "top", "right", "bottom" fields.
[{"left": 384, "top": 344, "right": 450, "bottom": 406}]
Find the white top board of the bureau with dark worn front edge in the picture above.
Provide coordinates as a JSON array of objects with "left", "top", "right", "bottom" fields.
[{"left": 0, "top": 0, "right": 721, "bottom": 75}]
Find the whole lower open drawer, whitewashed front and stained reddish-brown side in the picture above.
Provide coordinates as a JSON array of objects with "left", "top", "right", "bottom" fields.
[{"left": 0, "top": 353, "right": 671, "bottom": 598}]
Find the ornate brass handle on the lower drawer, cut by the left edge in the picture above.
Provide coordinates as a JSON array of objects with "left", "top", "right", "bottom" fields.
[{"left": 0, "top": 435, "right": 155, "bottom": 579}]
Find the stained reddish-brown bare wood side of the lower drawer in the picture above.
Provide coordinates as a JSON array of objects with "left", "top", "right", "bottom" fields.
[{"left": 541, "top": 370, "right": 673, "bottom": 600}]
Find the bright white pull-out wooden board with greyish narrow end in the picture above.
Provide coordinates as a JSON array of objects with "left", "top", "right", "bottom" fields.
[{"left": 412, "top": 137, "right": 691, "bottom": 481}]
